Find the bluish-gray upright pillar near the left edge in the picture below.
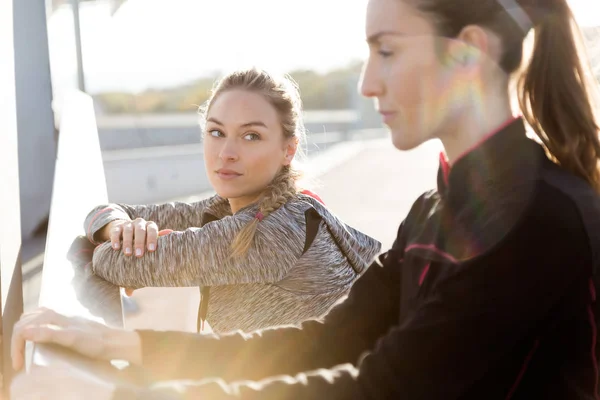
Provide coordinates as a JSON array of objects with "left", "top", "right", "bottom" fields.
[{"left": 13, "top": 0, "right": 56, "bottom": 239}]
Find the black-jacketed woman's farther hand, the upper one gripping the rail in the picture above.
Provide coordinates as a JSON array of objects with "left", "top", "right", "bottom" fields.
[{"left": 11, "top": 308, "right": 142, "bottom": 370}]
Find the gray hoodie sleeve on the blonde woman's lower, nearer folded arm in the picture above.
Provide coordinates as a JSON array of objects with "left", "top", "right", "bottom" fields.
[{"left": 92, "top": 203, "right": 305, "bottom": 289}]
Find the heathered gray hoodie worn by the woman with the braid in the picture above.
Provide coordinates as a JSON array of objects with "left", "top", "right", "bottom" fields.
[{"left": 85, "top": 194, "right": 381, "bottom": 333}]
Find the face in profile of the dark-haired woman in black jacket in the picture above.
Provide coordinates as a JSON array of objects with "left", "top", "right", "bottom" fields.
[{"left": 361, "top": 0, "right": 462, "bottom": 150}]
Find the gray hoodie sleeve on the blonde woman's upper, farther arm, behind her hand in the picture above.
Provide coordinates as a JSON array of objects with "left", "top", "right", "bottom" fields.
[{"left": 84, "top": 198, "right": 212, "bottom": 244}]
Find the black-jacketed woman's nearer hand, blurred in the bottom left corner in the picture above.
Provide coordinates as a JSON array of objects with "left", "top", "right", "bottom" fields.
[{"left": 10, "top": 367, "right": 115, "bottom": 400}]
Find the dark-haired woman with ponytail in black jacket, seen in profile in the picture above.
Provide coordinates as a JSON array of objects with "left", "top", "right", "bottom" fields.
[{"left": 13, "top": 0, "right": 600, "bottom": 400}]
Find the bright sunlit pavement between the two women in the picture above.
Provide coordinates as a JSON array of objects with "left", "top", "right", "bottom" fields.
[{"left": 315, "top": 138, "right": 441, "bottom": 250}]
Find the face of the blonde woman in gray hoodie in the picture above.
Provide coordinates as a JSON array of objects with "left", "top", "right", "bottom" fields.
[{"left": 204, "top": 90, "right": 296, "bottom": 204}]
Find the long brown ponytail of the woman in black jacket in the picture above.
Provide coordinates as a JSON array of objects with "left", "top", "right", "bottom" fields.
[{"left": 519, "top": 0, "right": 600, "bottom": 192}]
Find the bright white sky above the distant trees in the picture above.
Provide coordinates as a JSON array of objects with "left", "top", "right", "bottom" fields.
[{"left": 48, "top": 0, "right": 600, "bottom": 93}]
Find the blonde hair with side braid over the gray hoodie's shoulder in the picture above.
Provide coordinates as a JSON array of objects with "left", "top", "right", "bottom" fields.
[{"left": 201, "top": 68, "right": 306, "bottom": 257}]
